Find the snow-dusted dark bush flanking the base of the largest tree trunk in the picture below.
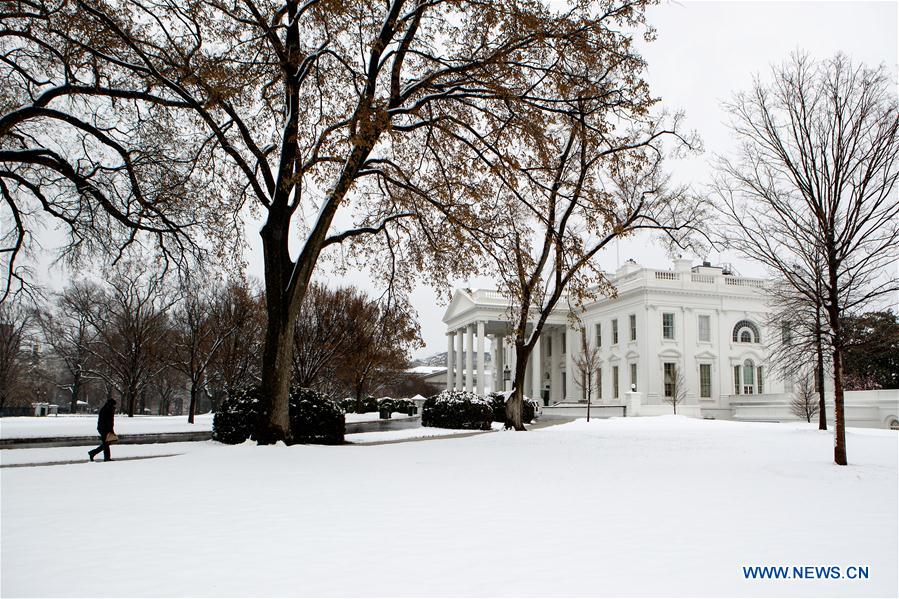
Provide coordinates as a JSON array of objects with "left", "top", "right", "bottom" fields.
[{"left": 212, "top": 387, "right": 345, "bottom": 445}]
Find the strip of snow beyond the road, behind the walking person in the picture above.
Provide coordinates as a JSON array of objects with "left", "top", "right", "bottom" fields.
[{"left": 0, "top": 413, "right": 212, "bottom": 439}]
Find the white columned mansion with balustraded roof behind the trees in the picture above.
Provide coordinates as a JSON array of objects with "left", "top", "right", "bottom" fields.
[{"left": 443, "top": 259, "right": 784, "bottom": 417}]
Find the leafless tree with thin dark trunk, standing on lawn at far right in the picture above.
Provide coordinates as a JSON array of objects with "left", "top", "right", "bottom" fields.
[{"left": 716, "top": 54, "right": 899, "bottom": 465}]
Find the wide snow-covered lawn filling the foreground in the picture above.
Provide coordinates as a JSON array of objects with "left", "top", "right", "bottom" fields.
[{"left": 0, "top": 417, "right": 899, "bottom": 597}]
